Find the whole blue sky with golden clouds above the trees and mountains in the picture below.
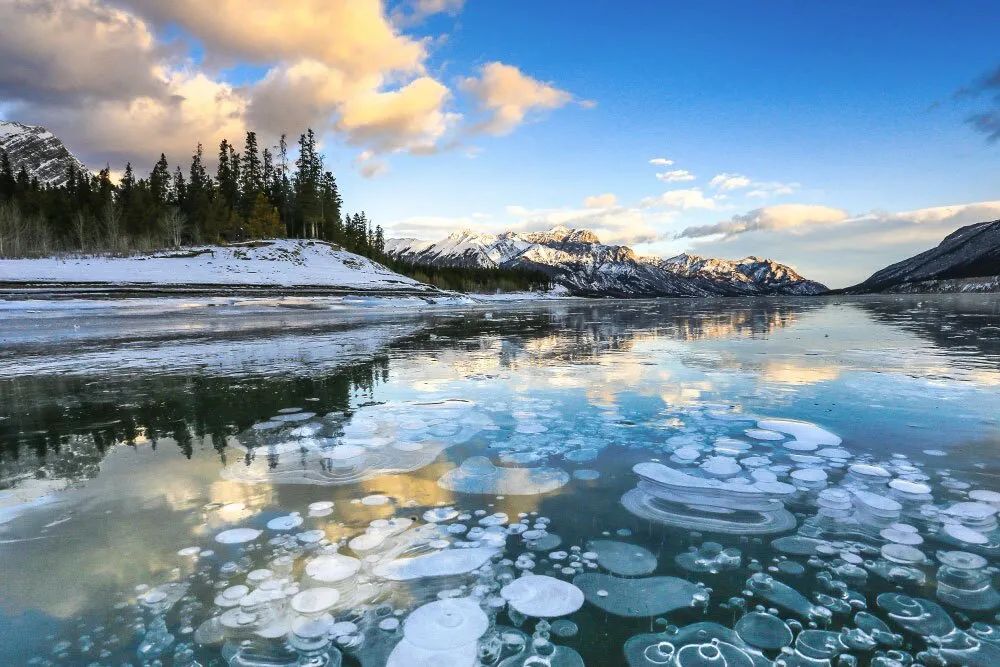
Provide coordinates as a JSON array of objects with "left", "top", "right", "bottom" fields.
[{"left": 0, "top": 0, "right": 1000, "bottom": 285}]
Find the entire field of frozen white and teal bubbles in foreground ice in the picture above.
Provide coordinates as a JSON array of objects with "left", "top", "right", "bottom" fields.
[{"left": 31, "top": 384, "right": 1000, "bottom": 667}]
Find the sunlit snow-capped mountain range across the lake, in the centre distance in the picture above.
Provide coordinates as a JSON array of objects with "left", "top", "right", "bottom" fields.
[{"left": 386, "top": 226, "right": 826, "bottom": 297}]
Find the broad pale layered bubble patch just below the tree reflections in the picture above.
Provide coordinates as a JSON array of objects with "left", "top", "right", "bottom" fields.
[{"left": 223, "top": 399, "right": 493, "bottom": 485}]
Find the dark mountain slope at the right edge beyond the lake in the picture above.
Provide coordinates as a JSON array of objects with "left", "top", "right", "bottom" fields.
[{"left": 844, "top": 220, "right": 1000, "bottom": 294}]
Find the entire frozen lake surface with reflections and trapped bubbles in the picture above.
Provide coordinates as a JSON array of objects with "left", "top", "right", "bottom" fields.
[{"left": 0, "top": 295, "right": 1000, "bottom": 667}]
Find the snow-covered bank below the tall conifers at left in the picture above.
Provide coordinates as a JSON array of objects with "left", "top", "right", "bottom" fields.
[{"left": 0, "top": 239, "right": 437, "bottom": 293}]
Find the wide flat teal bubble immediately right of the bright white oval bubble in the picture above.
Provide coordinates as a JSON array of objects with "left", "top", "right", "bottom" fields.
[{"left": 573, "top": 572, "right": 705, "bottom": 618}]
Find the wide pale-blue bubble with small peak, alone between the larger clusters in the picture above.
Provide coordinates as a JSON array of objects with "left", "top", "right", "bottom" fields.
[{"left": 438, "top": 456, "right": 569, "bottom": 496}]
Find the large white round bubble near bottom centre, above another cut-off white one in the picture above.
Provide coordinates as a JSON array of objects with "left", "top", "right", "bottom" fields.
[{"left": 403, "top": 597, "right": 490, "bottom": 651}]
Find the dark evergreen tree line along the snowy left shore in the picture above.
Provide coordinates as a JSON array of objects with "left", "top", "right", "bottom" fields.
[{"left": 0, "top": 129, "right": 549, "bottom": 291}]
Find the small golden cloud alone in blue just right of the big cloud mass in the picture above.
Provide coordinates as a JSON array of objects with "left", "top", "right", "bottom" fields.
[{"left": 459, "top": 62, "right": 573, "bottom": 135}]
